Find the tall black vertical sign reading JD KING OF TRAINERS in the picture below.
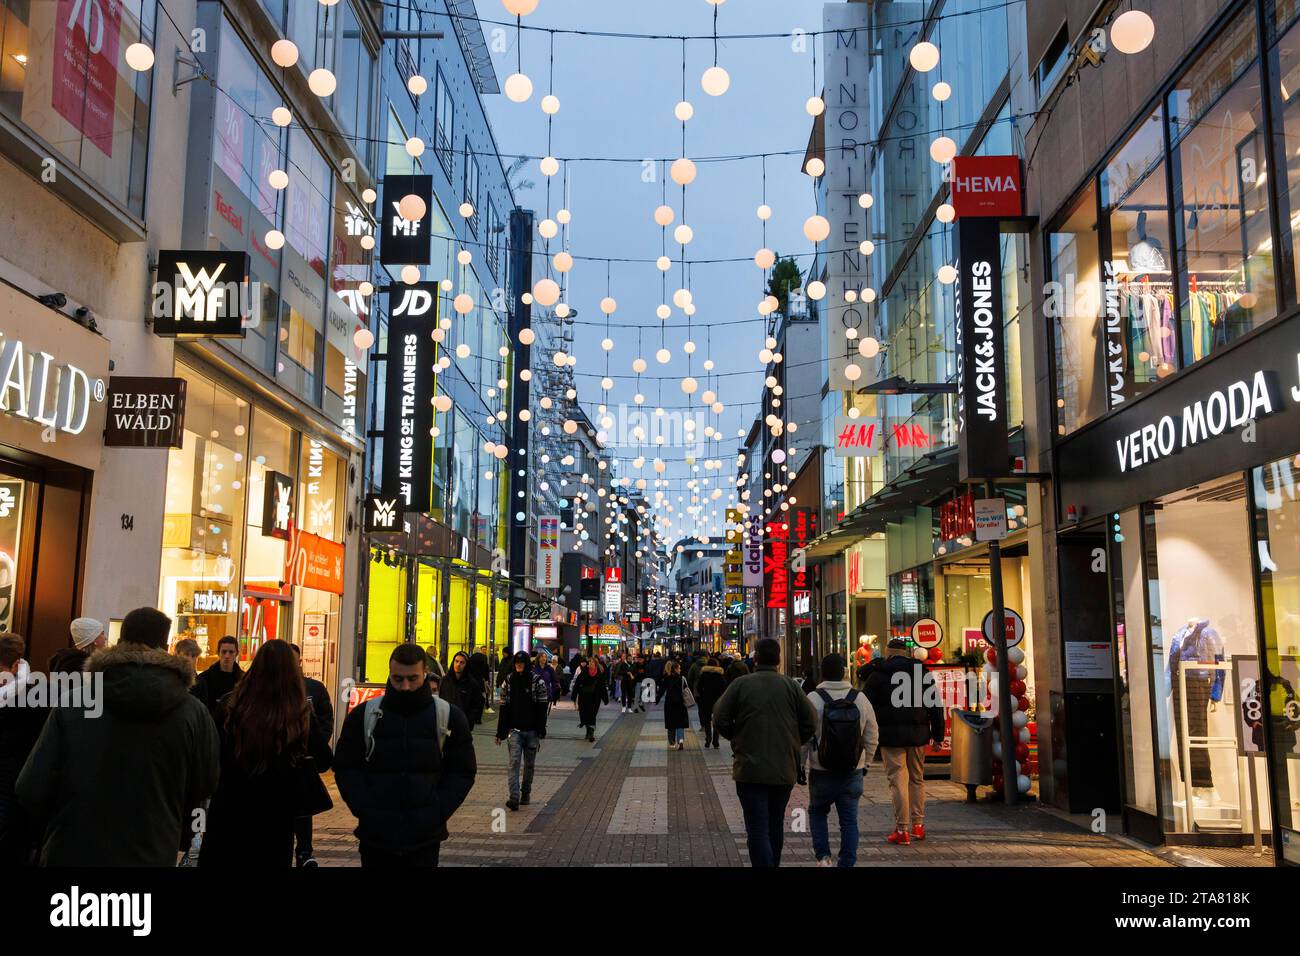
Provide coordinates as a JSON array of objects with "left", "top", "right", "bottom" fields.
[{"left": 384, "top": 282, "right": 438, "bottom": 514}]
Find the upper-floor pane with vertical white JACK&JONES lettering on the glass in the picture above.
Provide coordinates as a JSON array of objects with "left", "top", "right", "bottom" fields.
[{"left": 1101, "top": 109, "right": 1178, "bottom": 408}]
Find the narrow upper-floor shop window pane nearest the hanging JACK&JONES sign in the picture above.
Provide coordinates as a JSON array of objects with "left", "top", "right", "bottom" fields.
[{"left": 1044, "top": 185, "right": 1105, "bottom": 434}]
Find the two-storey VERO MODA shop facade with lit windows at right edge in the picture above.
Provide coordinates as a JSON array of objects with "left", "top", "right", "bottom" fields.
[{"left": 1028, "top": 0, "right": 1300, "bottom": 864}]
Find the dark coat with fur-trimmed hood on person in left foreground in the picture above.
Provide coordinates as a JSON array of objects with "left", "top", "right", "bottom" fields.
[{"left": 17, "top": 644, "right": 220, "bottom": 866}]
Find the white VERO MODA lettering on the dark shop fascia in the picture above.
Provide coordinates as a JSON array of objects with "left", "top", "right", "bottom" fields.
[{"left": 1115, "top": 366, "right": 1284, "bottom": 472}]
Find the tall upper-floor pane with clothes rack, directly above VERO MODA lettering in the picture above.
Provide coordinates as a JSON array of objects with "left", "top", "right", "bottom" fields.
[{"left": 1169, "top": 9, "right": 1278, "bottom": 364}]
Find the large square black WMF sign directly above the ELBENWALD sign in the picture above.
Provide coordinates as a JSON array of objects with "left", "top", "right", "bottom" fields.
[{"left": 152, "top": 250, "right": 250, "bottom": 338}]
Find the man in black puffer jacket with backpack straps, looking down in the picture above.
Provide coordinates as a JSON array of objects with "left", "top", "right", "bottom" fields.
[{"left": 334, "top": 644, "right": 478, "bottom": 868}]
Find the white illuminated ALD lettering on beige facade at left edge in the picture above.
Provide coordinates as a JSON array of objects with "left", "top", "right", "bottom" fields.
[{"left": 0, "top": 337, "right": 104, "bottom": 434}]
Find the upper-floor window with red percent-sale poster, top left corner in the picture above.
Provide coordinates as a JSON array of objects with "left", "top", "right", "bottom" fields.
[{"left": 0, "top": 0, "right": 155, "bottom": 216}]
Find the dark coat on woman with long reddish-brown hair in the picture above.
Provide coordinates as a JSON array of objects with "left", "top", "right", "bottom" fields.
[{"left": 199, "top": 704, "right": 333, "bottom": 869}]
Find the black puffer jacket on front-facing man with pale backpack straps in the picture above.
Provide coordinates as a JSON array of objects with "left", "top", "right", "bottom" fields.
[{"left": 334, "top": 685, "right": 478, "bottom": 855}]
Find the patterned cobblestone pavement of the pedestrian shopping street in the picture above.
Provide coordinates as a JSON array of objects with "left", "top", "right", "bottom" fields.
[{"left": 316, "top": 701, "right": 1169, "bottom": 866}]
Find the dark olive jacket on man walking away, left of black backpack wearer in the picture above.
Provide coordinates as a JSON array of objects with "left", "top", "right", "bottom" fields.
[{"left": 714, "top": 666, "right": 816, "bottom": 787}]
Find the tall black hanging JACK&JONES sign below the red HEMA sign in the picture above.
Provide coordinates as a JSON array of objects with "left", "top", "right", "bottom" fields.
[{"left": 953, "top": 219, "right": 1011, "bottom": 481}]
